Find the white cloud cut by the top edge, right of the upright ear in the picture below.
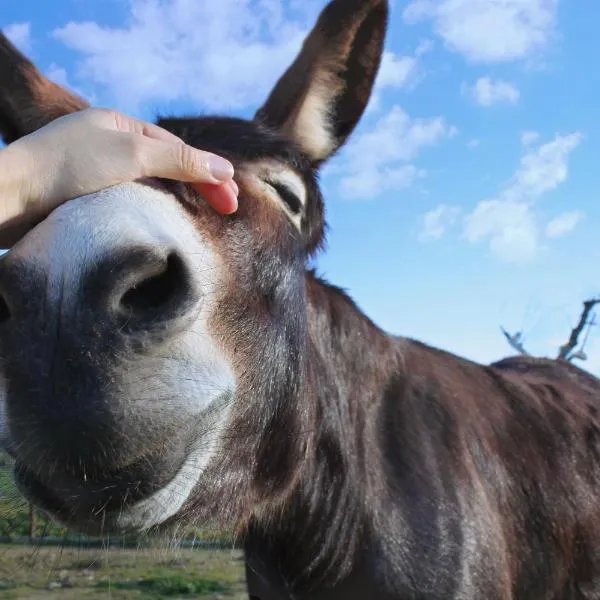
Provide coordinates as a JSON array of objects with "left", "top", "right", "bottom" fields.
[{"left": 404, "top": 0, "right": 558, "bottom": 63}]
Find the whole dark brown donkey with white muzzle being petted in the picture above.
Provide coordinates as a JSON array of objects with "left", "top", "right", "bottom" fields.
[{"left": 0, "top": 0, "right": 600, "bottom": 600}]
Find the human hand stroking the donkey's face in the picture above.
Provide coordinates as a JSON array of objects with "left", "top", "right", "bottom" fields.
[{"left": 0, "top": 108, "right": 238, "bottom": 243}]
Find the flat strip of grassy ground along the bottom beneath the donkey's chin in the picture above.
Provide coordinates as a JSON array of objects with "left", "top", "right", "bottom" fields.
[{"left": 0, "top": 544, "right": 248, "bottom": 600}]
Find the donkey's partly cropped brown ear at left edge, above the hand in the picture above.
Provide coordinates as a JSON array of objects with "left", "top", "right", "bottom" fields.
[{"left": 0, "top": 32, "right": 89, "bottom": 144}]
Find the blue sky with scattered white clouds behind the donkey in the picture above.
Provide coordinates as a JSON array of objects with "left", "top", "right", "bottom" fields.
[{"left": 1, "top": 0, "right": 600, "bottom": 373}]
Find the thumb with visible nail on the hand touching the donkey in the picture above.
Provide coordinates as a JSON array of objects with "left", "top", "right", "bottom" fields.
[{"left": 136, "top": 136, "right": 234, "bottom": 184}]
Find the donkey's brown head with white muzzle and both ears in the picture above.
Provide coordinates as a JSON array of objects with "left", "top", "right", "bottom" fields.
[{"left": 0, "top": 0, "right": 388, "bottom": 533}]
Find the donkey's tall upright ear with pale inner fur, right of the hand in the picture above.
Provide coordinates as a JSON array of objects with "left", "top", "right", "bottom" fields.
[{"left": 255, "top": 0, "right": 388, "bottom": 164}]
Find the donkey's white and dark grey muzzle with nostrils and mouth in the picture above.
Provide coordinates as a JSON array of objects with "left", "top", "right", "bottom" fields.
[{"left": 0, "top": 183, "right": 235, "bottom": 534}]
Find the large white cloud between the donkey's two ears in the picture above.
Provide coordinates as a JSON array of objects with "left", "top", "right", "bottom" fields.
[{"left": 53, "top": 0, "right": 314, "bottom": 111}]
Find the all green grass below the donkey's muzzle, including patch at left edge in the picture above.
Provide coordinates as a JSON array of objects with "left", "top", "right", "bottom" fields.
[{"left": 0, "top": 452, "right": 248, "bottom": 600}]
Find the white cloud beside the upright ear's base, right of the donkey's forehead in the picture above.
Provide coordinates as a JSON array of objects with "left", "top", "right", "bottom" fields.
[{"left": 330, "top": 106, "right": 456, "bottom": 199}]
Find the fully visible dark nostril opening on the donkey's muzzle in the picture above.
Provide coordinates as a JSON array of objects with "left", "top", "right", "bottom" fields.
[{"left": 120, "top": 252, "right": 190, "bottom": 317}]
